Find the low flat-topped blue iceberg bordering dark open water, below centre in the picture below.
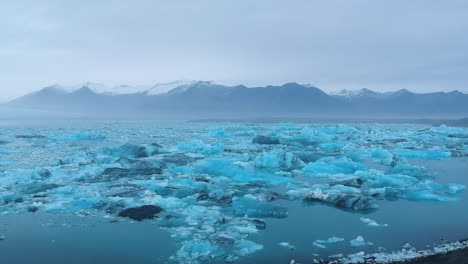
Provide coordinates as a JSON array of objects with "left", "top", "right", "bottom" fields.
[{"left": 232, "top": 197, "right": 288, "bottom": 218}]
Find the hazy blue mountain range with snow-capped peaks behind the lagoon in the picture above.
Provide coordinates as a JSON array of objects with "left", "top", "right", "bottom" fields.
[{"left": 0, "top": 81, "right": 468, "bottom": 119}]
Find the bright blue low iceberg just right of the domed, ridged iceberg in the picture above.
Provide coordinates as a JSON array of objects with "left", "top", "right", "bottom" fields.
[{"left": 302, "top": 157, "right": 367, "bottom": 175}]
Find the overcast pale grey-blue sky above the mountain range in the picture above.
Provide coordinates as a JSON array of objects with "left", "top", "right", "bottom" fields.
[{"left": 0, "top": 0, "right": 468, "bottom": 100}]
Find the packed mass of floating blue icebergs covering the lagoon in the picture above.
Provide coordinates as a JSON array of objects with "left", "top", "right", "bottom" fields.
[{"left": 0, "top": 124, "right": 468, "bottom": 263}]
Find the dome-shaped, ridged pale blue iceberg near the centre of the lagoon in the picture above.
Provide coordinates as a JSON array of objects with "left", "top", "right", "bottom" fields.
[{"left": 254, "top": 149, "right": 305, "bottom": 170}]
